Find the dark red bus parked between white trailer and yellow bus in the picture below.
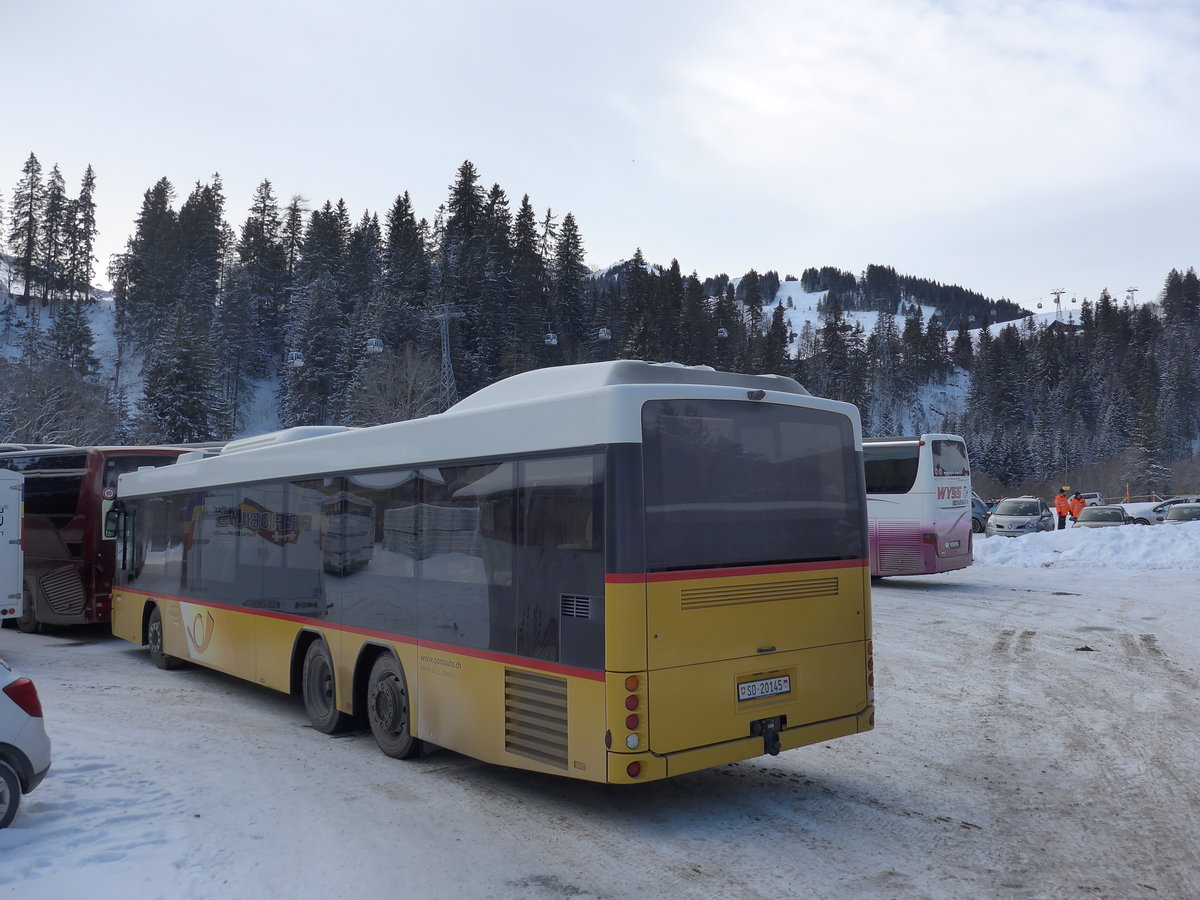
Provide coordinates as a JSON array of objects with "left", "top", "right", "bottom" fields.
[{"left": 0, "top": 446, "right": 187, "bottom": 634}]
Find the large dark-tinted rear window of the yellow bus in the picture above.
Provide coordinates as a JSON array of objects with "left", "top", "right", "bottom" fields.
[{"left": 642, "top": 400, "right": 866, "bottom": 571}]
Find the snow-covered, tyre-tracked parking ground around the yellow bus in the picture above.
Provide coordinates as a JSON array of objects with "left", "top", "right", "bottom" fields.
[{"left": 0, "top": 524, "right": 1200, "bottom": 900}]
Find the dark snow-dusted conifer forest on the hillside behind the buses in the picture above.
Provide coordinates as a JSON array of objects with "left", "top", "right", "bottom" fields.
[{"left": 0, "top": 154, "right": 1200, "bottom": 492}]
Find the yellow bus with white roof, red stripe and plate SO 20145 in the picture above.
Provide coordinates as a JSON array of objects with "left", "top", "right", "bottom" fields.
[{"left": 108, "top": 360, "right": 874, "bottom": 784}]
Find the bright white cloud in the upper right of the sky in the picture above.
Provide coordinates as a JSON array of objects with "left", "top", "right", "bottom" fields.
[{"left": 658, "top": 0, "right": 1200, "bottom": 218}]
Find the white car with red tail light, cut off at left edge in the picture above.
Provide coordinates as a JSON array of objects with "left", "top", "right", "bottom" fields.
[{"left": 0, "top": 659, "right": 50, "bottom": 828}]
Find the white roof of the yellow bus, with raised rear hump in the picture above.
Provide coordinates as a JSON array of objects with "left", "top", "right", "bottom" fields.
[{"left": 118, "top": 360, "right": 862, "bottom": 497}]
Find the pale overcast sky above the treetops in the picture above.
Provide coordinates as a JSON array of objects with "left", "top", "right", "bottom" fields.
[{"left": 0, "top": 0, "right": 1200, "bottom": 306}]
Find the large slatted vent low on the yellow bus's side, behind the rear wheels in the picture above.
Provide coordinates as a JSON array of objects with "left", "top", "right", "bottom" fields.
[{"left": 504, "top": 668, "right": 566, "bottom": 769}]
